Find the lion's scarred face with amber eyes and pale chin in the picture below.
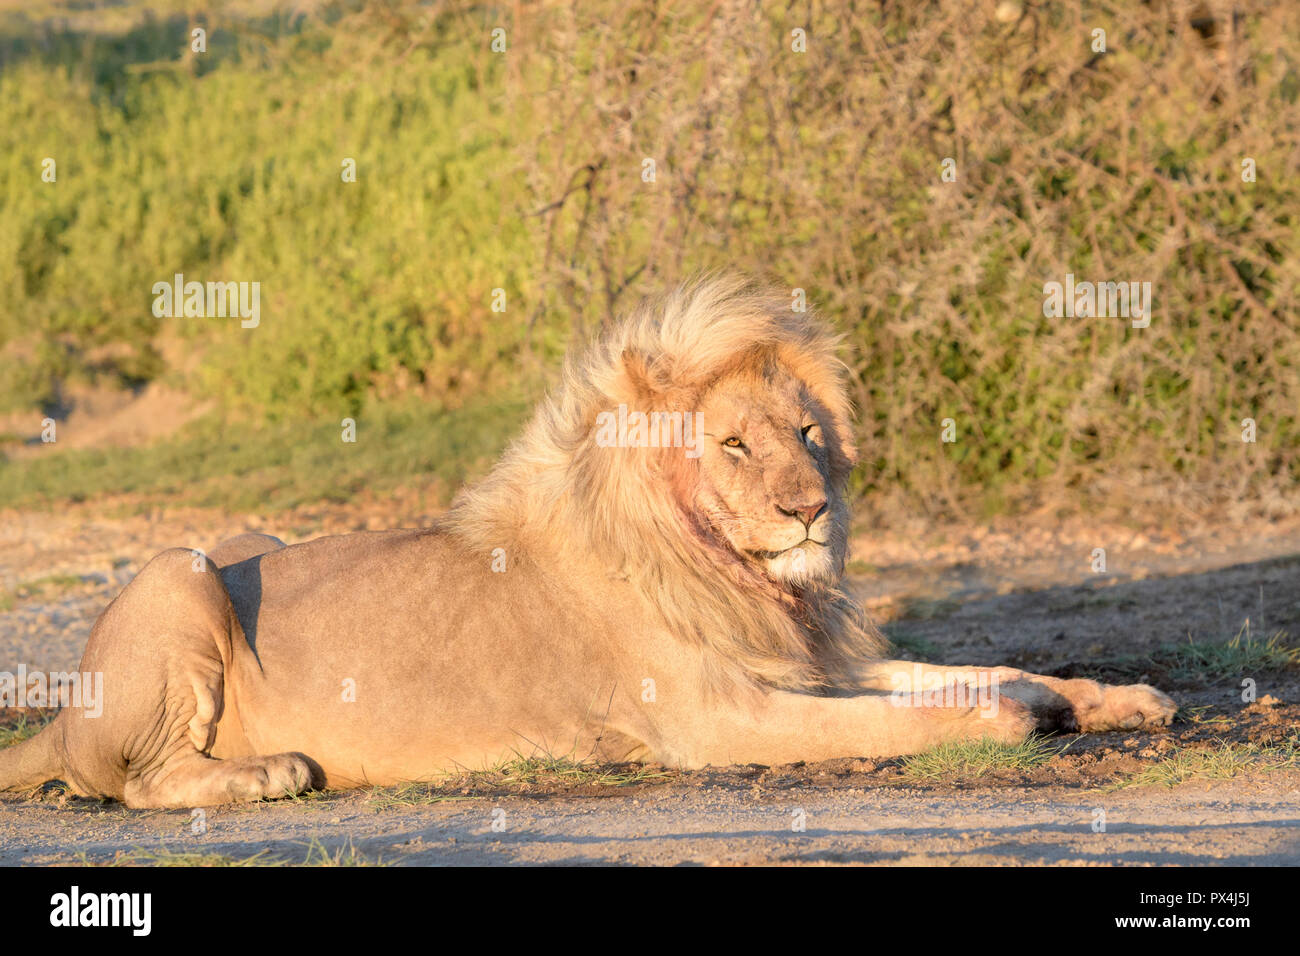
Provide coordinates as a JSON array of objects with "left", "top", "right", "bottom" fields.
[{"left": 696, "top": 364, "right": 849, "bottom": 585}]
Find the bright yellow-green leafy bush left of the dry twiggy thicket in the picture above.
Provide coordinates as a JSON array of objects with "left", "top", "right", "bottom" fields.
[{"left": 0, "top": 3, "right": 532, "bottom": 420}]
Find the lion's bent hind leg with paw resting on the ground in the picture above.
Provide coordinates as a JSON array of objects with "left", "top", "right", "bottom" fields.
[{"left": 64, "top": 549, "right": 317, "bottom": 808}]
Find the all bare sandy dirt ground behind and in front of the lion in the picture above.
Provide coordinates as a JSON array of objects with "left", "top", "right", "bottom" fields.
[{"left": 0, "top": 496, "right": 1300, "bottom": 865}]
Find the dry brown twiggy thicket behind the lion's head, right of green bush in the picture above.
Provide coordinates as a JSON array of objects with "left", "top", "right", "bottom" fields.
[{"left": 516, "top": 1, "right": 1300, "bottom": 512}]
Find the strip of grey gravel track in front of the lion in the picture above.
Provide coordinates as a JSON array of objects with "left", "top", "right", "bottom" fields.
[{"left": 0, "top": 773, "right": 1300, "bottom": 866}]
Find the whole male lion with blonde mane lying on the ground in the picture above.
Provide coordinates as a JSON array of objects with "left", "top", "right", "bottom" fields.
[{"left": 0, "top": 278, "right": 1175, "bottom": 806}]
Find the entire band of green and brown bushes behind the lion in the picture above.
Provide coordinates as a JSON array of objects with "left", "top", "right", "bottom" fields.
[{"left": 0, "top": 0, "right": 1300, "bottom": 512}]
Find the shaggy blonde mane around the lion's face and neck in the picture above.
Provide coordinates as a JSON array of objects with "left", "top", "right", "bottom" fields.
[{"left": 441, "top": 276, "right": 884, "bottom": 689}]
